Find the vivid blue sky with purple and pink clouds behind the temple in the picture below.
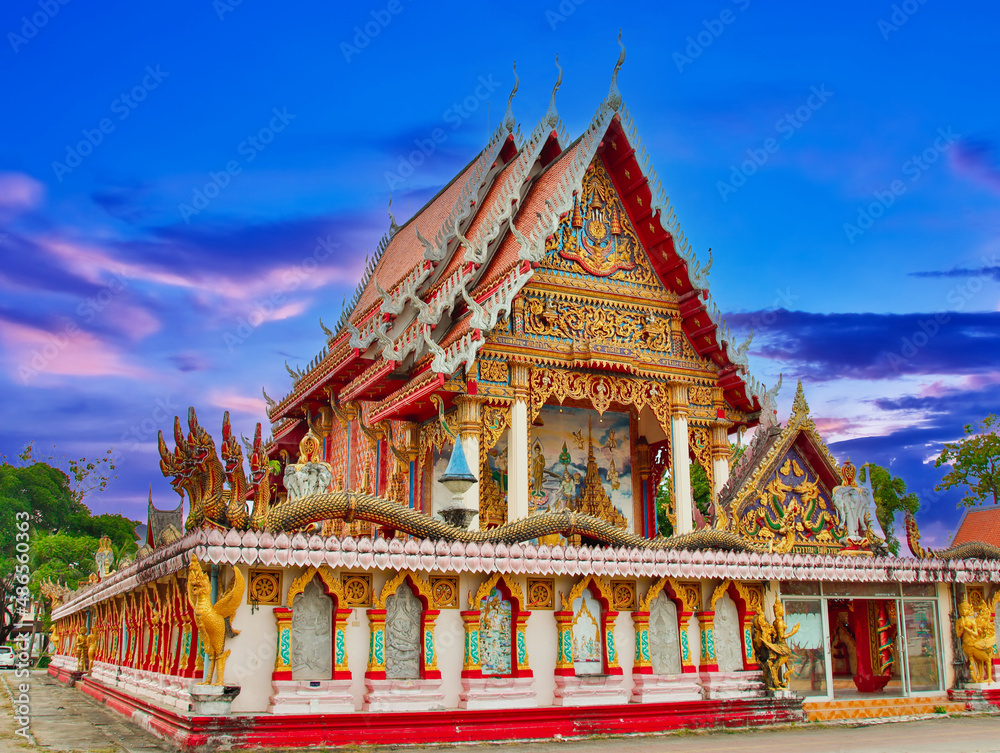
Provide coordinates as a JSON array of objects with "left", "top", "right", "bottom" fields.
[{"left": 0, "top": 0, "right": 1000, "bottom": 545}]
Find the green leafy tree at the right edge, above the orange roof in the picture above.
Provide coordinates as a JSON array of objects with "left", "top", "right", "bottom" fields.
[{"left": 934, "top": 415, "right": 1000, "bottom": 507}]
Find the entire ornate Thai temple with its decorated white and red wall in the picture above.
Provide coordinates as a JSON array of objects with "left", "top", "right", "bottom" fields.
[{"left": 48, "top": 51, "right": 1000, "bottom": 747}]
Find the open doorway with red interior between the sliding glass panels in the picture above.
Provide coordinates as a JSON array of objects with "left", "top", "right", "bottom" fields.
[{"left": 827, "top": 599, "right": 906, "bottom": 698}]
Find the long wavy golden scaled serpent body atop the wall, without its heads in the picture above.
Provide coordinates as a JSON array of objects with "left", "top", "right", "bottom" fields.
[{"left": 266, "top": 491, "right": 769, "bottom": 553}]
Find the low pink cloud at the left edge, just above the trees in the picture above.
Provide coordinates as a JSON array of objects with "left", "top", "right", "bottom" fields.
[{"left": 0, "top": 320, "right": 149, "bottom": 384}]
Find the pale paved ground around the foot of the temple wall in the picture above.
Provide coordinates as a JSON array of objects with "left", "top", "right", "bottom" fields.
[{"left": 0, "top": 672, "right": 1000, "bottom": 753}]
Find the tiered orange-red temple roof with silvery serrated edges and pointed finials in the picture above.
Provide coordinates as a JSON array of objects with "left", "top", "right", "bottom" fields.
[{"left": 268, "top": 49, "right": 765, "bottom": 452}]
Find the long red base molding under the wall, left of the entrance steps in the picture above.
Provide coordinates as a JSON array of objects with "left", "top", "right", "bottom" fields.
[{"left": 62, "top": 677, "right": 805, "bottom": 749}]
